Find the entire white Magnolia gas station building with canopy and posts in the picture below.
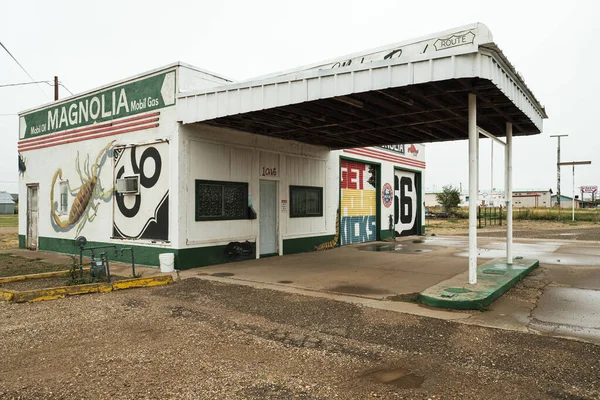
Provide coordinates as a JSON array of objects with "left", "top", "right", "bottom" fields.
[{"left": 19, "top": 23, "right": 547, "bottom": 282}]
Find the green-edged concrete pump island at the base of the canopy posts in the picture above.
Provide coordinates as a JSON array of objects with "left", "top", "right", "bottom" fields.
[{"left": 419, "top": 259, "right": 539, "bottom": 310}]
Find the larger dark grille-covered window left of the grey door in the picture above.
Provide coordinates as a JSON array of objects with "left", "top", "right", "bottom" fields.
[{"left": 196, "top": 180, "right": 248, "bottom": 221}]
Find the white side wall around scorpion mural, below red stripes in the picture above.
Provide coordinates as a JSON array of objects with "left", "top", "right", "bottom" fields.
[{"left": 19, "top": 67, "right": 179, "bottom": 252}]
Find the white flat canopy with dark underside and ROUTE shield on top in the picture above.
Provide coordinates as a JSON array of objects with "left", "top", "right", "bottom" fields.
[{"left": 177, "top": 23, "right": 547, "bottom": 149}]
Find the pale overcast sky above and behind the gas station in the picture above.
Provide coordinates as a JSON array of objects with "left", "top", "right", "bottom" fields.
[{"left": 0, "top": 0, "right": 600, "bottom": 197}]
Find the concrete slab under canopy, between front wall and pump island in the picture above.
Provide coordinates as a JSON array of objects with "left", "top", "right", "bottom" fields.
[{"left": 180, "top": 239, "right": 465, "bottom": 300}]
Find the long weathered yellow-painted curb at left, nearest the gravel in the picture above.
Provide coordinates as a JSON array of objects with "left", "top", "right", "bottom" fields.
[{"left": 0, "top": 271, "right": 173, "bottom": 303}]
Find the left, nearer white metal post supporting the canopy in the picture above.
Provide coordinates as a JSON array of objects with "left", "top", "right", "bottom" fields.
[{"left": 469, "top": 93, "right": 479, "bottom": 285}]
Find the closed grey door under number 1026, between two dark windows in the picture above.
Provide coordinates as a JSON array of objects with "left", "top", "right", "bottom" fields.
[{"left": 258, "top": 181, "right": 277, "bottom": 255}]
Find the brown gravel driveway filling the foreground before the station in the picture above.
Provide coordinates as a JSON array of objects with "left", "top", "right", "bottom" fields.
[{"left": 0, "top": 279, "right": 600, "bottom": 400}]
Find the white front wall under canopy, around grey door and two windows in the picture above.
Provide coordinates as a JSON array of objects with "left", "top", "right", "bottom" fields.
[{"left": 178, "top": 124, "right": 337, "bottom": 254}]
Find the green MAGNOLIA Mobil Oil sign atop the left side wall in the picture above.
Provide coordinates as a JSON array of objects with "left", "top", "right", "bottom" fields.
[{"left": 20, "top": 70, "right": 175, "bottom": 139}]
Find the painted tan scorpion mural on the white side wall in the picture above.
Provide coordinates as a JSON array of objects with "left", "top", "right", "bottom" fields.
[{"left": 50, "top": 140, "right": 115, "bottom": 237}]
